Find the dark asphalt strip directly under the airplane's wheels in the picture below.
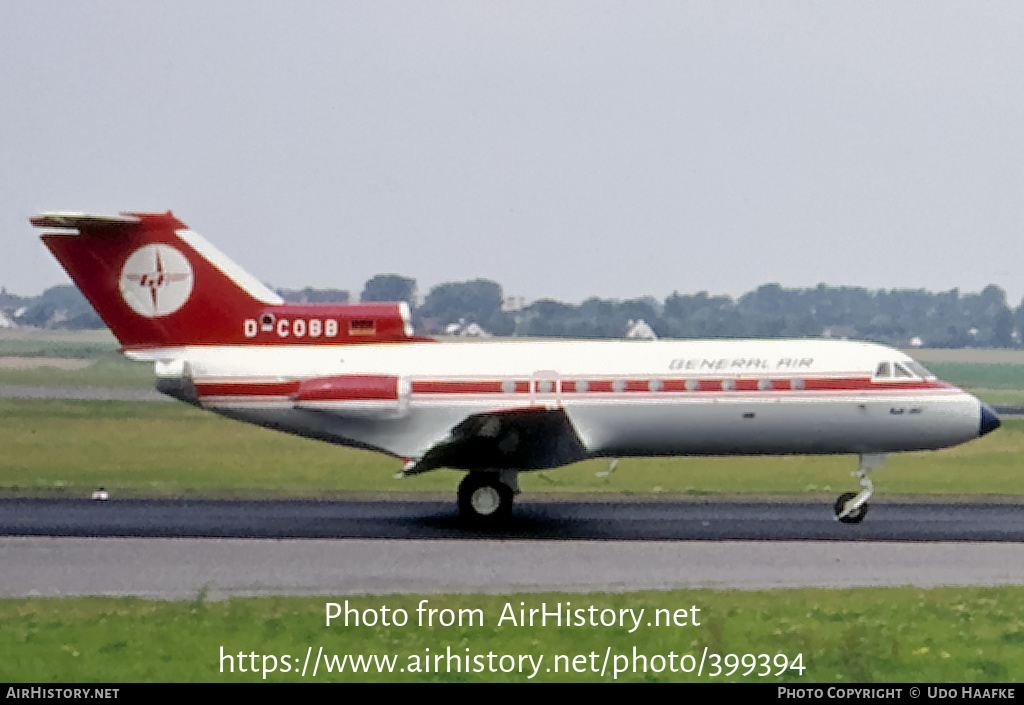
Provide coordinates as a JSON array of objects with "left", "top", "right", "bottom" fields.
[{"left": 0, "top": 496, "right": 1024, "bottom": 542}]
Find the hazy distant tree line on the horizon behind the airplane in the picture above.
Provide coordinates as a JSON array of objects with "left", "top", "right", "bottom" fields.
[{"left": 12, "top": 274, "right": 1024, "bottom": 347}]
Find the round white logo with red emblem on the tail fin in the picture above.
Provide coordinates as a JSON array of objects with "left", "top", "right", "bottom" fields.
[{"left": 120, "top": 245, "right": 194, "bottom": 319}]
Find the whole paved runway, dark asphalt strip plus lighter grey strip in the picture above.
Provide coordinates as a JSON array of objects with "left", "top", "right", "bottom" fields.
[{"left": 0, "top": 500, "right": 1024, "bottom": 598}]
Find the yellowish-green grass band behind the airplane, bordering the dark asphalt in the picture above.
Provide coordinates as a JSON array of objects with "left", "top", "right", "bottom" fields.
[{"left": 0, "top": 399, "right": 1024, "bottom": 497}]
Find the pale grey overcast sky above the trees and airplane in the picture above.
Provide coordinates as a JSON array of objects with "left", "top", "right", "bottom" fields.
[{"left": 0, "top": 0, "right": 1024, "bottom": 306}]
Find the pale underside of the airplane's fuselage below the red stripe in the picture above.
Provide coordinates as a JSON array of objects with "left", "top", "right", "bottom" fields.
[{"left": 209, "top": 385, "right": 979, "bottom": 458}]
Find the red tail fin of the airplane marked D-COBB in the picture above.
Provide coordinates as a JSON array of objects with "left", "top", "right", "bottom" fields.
[{"left": 32, "top": 211, "right": 412, "bottom": 349}]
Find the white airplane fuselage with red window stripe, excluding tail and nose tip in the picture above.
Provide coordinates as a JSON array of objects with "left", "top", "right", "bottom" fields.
[{"left": 153, "top": 340, "right": 981, "bottom": 459}]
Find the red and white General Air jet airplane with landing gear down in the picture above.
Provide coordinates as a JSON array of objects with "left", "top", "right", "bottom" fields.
[{"left": 31, "top": 211, "right": 1000, "bottom": 526}]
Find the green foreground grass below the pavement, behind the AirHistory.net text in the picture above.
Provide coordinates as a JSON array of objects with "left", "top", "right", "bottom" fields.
[{"left": 0, "top": 587, "right": 1024, "bottom": 683}]
